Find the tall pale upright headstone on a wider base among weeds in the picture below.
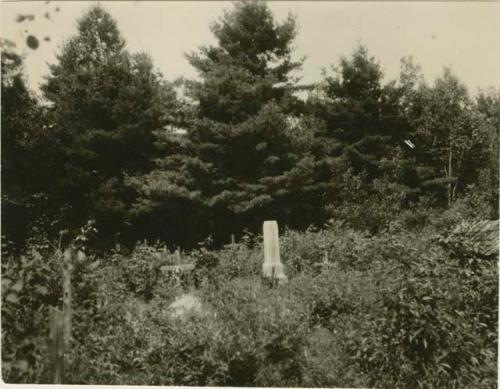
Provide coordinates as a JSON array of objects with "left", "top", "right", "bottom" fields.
[{"left": 262, "top": 220, "right": 287, "bottom": 284}]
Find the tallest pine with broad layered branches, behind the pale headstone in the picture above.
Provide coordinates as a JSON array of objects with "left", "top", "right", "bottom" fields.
[{"left": 129, "top": 1, "right": 332, "bottom": 246}]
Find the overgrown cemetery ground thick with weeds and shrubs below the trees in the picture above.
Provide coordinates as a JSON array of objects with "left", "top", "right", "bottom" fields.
[{"left": 2, "top": 214, "right": 498, "bottom": 388}]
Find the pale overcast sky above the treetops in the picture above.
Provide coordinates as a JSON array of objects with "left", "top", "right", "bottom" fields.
[{"left": 1, "top": 1, "right": 500, "bottom": 93}]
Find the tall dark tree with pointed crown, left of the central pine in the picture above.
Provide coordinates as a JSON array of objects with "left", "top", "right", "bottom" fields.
[{"left": 42, "top": 6, "right": 175, "bottom": 242}]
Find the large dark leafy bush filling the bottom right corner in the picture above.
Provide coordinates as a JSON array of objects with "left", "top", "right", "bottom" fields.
[{"left": 352, "top": 238, "right": 498, "bottom": 387}]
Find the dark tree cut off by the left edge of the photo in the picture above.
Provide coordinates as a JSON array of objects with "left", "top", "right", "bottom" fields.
[{"left": 1, "top": 50, "right": 54, "bottom": 244}]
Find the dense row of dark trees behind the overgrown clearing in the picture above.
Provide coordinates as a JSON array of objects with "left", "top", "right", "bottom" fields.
[{"left": 1, "top": 2, "right": 500, "bottom": 249}]
